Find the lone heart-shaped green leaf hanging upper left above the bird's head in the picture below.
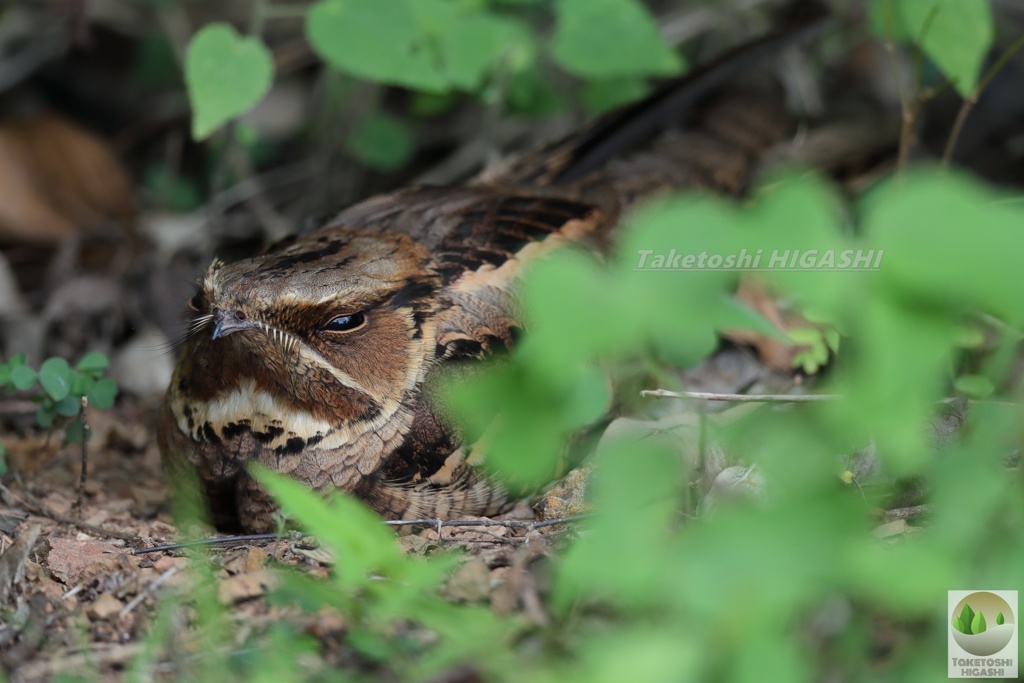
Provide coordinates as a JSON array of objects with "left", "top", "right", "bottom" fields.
[{"left": 185, "top": 24, "right": 273, "bottom": 140}]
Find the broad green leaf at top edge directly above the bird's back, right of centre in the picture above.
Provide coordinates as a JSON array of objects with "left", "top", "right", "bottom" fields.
[{"left": 552, "top": 0, "right": 683, "bottom": 79}]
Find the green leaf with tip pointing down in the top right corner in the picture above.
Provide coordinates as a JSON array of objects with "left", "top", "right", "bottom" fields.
[{"left": 893, "top": 0, "right": 994, "bottom": 97}]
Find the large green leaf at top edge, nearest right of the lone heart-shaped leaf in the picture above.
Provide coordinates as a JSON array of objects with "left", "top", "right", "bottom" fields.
[{"left": 306, "top": 0, "right": 449, "bottom": 91}]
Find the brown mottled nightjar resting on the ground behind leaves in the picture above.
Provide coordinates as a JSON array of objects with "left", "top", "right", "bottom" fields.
[{"left": 159, "top": 13, "right": 831, "bottom": 532}]
